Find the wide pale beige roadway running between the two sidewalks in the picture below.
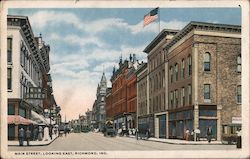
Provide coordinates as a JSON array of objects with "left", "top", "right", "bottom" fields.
[{"left": 9, "top": 133, "right": 236, "bottom": 151}]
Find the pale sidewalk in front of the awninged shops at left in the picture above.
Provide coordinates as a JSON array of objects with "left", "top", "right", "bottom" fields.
[{"left": 8, "top": 134, "right": 58, "bottom": 146}]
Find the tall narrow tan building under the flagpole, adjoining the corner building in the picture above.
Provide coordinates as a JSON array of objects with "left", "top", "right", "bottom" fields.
[{"left": 144, "top": 29, "right": 178, "bottom": 138}]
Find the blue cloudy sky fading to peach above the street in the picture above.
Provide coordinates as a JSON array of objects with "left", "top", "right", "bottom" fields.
[{"left": 8, "top": 8, "right": 241, "bottom": 121}]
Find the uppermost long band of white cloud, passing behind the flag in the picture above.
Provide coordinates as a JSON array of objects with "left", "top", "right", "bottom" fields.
[{"left": 30, "top": 11, "right": 187, "bottom": 35}]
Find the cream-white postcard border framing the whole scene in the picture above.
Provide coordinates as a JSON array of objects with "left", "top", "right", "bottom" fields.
[{"left": 0, "top": 0, "right": 250, "bottom": 158}]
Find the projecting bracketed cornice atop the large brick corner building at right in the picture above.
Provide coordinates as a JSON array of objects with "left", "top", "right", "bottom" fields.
[{"left": 164, "top": 21, "right": 241, "bottom": 50}]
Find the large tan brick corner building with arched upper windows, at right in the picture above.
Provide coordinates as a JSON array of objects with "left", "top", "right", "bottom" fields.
[{"left": 165, "top": 22, "right": 241, "bottom": 140}]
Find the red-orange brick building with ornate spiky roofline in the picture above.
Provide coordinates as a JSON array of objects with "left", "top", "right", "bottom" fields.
[{"left": 110, "top": 55, "right": 141, "bottom": 129}]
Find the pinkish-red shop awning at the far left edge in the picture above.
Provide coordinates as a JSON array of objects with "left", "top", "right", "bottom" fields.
[{"left": 8, "top": 115, "right": 37, "bottom": 125}]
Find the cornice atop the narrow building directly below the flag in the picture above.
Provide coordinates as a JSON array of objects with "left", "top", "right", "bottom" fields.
[{"left": 143, "top": 29, "right": 179, "bottom": 53}]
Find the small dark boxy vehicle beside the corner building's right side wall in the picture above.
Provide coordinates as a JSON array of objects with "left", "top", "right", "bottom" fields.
[{"left": 222, "top": 124, "right": 241, "bottom": 145}]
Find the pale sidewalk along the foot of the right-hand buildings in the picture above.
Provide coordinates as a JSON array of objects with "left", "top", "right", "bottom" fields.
[{"left": 128, "top": 135, "right": 222, "bottom": 145}]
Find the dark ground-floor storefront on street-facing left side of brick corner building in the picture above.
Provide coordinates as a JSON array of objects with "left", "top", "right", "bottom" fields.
[{"left": 168, "top": 109, "right": 194, "bottom": 139}]
